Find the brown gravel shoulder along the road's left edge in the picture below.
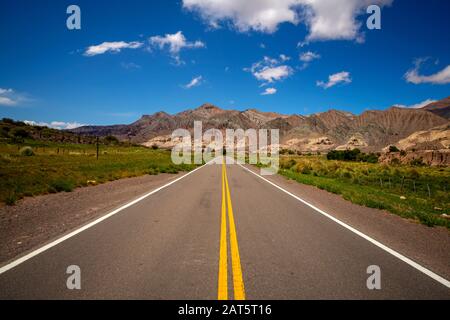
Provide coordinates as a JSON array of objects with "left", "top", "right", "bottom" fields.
[{"left": 0, "top": 173, "right": 186, "bottom": 265}]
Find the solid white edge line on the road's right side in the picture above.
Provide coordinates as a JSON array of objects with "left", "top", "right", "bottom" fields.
[{"left": 239, "top": 164, "right": 450, "bottom": 288}]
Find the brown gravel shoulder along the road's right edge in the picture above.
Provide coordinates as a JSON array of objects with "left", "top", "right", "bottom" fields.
[{"left": 246, "top": 166, "right": 450, "bottom": 279}]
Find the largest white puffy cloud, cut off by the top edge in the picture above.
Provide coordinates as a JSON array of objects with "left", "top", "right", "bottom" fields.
[{"left": 183, "top": 0, "right": 393, "bottom": 41}]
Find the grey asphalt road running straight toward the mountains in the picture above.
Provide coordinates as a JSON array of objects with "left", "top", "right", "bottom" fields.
[{"left": 0, "top": 160, "right": 450, "bottom": 300}]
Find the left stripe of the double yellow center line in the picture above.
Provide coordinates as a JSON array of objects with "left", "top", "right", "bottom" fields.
[{"left": 218, "top": 161, "right": 228, "bottom": 300}]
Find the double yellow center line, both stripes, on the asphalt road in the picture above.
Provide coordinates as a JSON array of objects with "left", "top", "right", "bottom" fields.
[{"left": 218, "top": 158, "right": 245, "bottom": 300}]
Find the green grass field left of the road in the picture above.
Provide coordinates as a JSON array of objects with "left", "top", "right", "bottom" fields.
[{"left": 0, "top": 140, "right": 195, "bottom": 205}]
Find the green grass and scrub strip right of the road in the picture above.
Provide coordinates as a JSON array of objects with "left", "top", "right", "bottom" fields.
[{"left": 256, "top": 156, "right": 450, "bottom": 228}]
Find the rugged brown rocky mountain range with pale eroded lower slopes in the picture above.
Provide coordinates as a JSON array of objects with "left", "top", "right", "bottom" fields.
[{"left": 72, "top": 98, "right": 449, "bottom": 152}]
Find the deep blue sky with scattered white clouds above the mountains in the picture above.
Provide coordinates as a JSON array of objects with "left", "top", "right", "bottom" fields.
[{"left": 0, "top": 0, "right": 450, "bottom": 127}]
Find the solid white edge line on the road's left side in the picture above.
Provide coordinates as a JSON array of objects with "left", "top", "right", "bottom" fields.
[{"left": 0, "top": 159, "right": 215, "bottom": 275}]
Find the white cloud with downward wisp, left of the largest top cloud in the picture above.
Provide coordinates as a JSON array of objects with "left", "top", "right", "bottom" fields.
[{"left": 149, "top": 31, "right": 206, "bottom": 64}]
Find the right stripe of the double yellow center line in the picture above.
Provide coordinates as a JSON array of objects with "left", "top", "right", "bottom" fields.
[{"left": 223, "top": 162, "right": 245, "bottom": 300}]
